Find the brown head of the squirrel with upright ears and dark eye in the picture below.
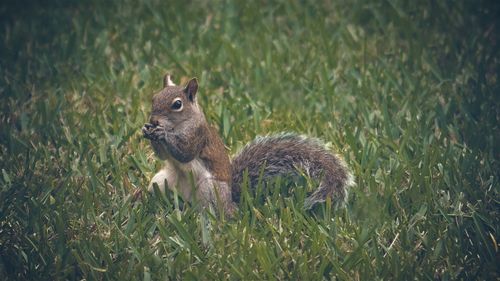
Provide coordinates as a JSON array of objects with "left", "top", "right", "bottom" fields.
[{"left": 150, "top": 74, "right": 204, "bottom": 130}]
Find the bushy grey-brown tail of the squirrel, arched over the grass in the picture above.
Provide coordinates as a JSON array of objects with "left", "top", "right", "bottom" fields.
[{"left": 231, "top": 134, "right": 353, "bottom": 209}]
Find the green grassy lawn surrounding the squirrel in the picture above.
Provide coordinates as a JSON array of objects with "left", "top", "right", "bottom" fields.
[{"left": 0, "top": 0, "right": 500, "bottom": 280}]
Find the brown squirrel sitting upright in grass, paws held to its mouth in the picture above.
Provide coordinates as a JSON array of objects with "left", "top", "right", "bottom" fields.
[{"left": 142, "top": 74, "right": 353, "bottom": 216}]
